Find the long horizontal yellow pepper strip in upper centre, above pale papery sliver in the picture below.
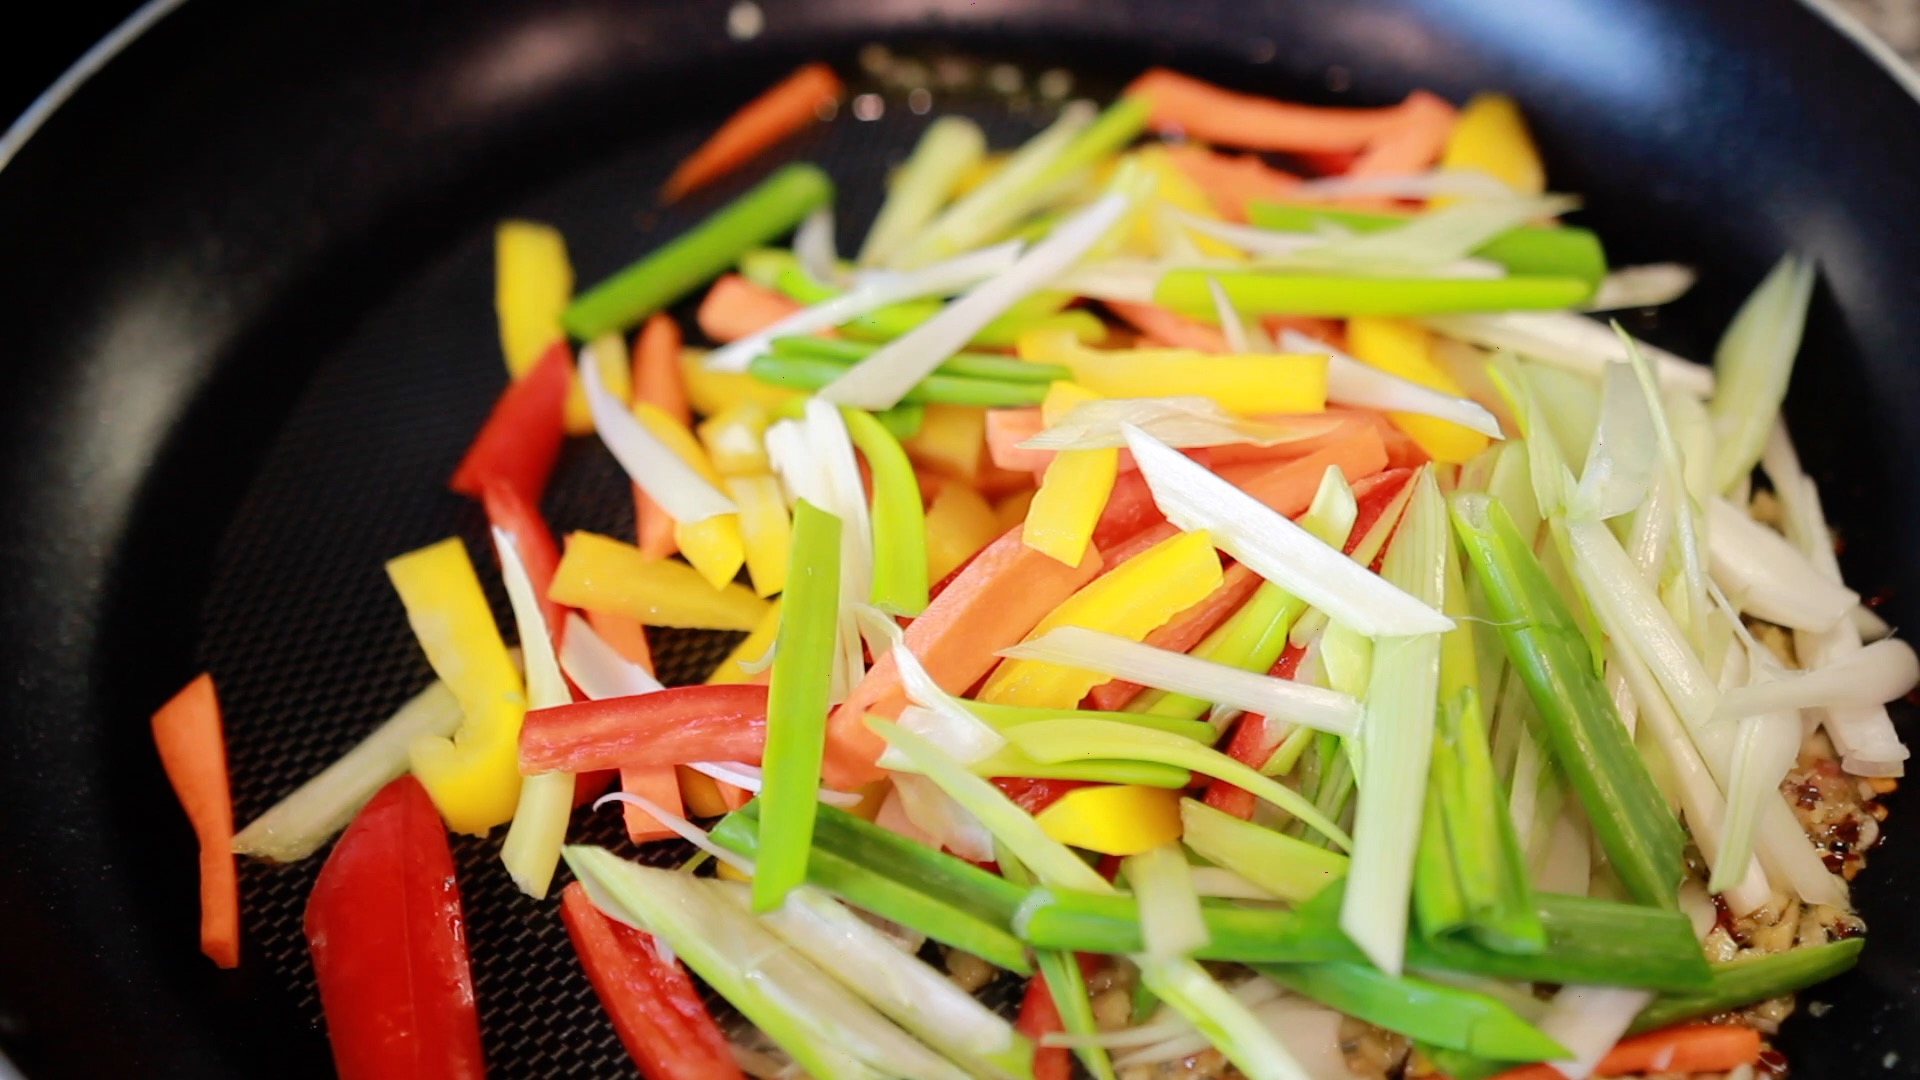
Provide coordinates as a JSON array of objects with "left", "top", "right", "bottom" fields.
[{"left": 1018, "top": 332, "right": 1327, "bottom": 415}]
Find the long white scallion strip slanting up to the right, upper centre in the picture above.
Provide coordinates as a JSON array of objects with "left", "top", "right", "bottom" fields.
[{"left": 820, "top": 194, "right": 1129, "bottom": 409}]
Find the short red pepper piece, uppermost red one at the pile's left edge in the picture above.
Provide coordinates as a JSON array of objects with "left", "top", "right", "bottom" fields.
[{"left": 449, "top": 340, "right": 574, "bottom": 505}]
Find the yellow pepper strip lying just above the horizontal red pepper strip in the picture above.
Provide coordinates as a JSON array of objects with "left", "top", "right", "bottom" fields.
[{"left": 547, "top": 532, "right": 766, "bottom": 630}]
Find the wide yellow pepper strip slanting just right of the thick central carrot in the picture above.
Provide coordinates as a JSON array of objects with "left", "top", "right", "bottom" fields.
[{"left": 981, "top": 530, "right": 1221, "bottom": 709}]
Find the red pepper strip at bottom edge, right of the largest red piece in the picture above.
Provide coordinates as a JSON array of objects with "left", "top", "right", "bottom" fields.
[{"left": 561, "top": 882, "right": 741, "bottom": 1080}]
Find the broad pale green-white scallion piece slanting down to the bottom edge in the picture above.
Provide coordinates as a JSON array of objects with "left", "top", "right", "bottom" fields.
[{"left": 566, "top": 847, "right": 966, "bottom": 1080}]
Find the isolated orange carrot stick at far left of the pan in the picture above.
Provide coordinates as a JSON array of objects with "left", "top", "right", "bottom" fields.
[{"left": 154, "top": 675, "right": 240, "bottom": 967}]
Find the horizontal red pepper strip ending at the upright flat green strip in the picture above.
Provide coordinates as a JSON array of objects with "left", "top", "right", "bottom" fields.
[{"left": 520, "top": 682, "right": 766, "bottom": 776}]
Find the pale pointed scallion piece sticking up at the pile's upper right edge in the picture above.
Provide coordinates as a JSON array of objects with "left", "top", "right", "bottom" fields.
[{"left": 1707, "top": 256, "right": 1814, "bottom": 492}]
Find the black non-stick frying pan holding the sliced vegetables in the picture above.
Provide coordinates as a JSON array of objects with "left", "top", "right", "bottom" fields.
[{"left": 0, "top": 0, "right": 1920, "bottom": 1078}]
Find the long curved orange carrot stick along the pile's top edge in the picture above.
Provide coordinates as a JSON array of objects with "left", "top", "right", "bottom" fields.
[{"left": 1127, "top": 67, "right": 1436, "bottom": 152}]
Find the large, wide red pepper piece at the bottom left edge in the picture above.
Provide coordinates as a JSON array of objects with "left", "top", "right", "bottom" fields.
[{"left": 305, "top": 776, "right": 486, "bottom": 1080}]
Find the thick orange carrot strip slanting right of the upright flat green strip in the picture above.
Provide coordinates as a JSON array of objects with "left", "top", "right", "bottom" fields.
[{"left": 826, "top": 528, "right": 1106, "bottom": 790}]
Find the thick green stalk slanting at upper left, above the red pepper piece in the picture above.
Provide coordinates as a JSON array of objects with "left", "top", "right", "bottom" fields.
[{"left": 561, "top": 161, "right": 833, "bottom": 340}]
